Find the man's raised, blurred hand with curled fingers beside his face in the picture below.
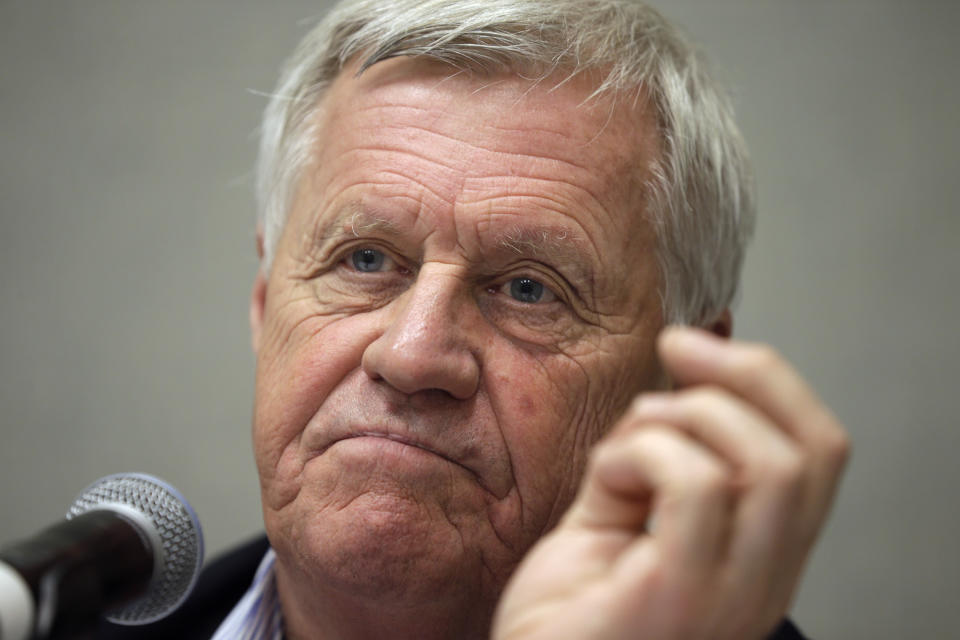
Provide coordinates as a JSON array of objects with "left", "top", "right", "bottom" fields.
[{"left": 493, "top": 328, "right": 849, "bottom": 640}]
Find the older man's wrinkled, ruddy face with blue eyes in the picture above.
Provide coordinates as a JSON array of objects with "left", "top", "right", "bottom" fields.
[{"left": 252, "top": 59, "right": 662, "bottom": 616}]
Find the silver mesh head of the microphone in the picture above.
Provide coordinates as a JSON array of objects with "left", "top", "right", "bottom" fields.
[{"left": 67, "top": 473, "right": 203, "bottom": 625}]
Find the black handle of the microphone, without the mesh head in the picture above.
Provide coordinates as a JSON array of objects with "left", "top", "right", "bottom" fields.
[{"left": 0, "top": 508, "right": 154, "bottom": 640}]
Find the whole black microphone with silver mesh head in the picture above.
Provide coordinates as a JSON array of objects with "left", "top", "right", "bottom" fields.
[{"left": 0, "top": 473, "right": 203, "bottom": 640}]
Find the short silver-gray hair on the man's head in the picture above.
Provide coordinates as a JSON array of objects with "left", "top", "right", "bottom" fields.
[{"left": 257, "top": 0, "right": 755, "bottom": 324}]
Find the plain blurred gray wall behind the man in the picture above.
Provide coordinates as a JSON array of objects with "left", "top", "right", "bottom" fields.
[{"left": 0, "top": 0, "right": 960, "bottom": 638}]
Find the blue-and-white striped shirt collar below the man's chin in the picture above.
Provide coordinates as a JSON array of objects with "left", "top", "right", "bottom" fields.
[{"left": 210, "top": 549, "right": 283, "bottom": 640}]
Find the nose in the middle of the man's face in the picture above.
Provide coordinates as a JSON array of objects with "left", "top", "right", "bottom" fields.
[{"left": 362, "top": 267, "right": 480, "bottom": 400}]
